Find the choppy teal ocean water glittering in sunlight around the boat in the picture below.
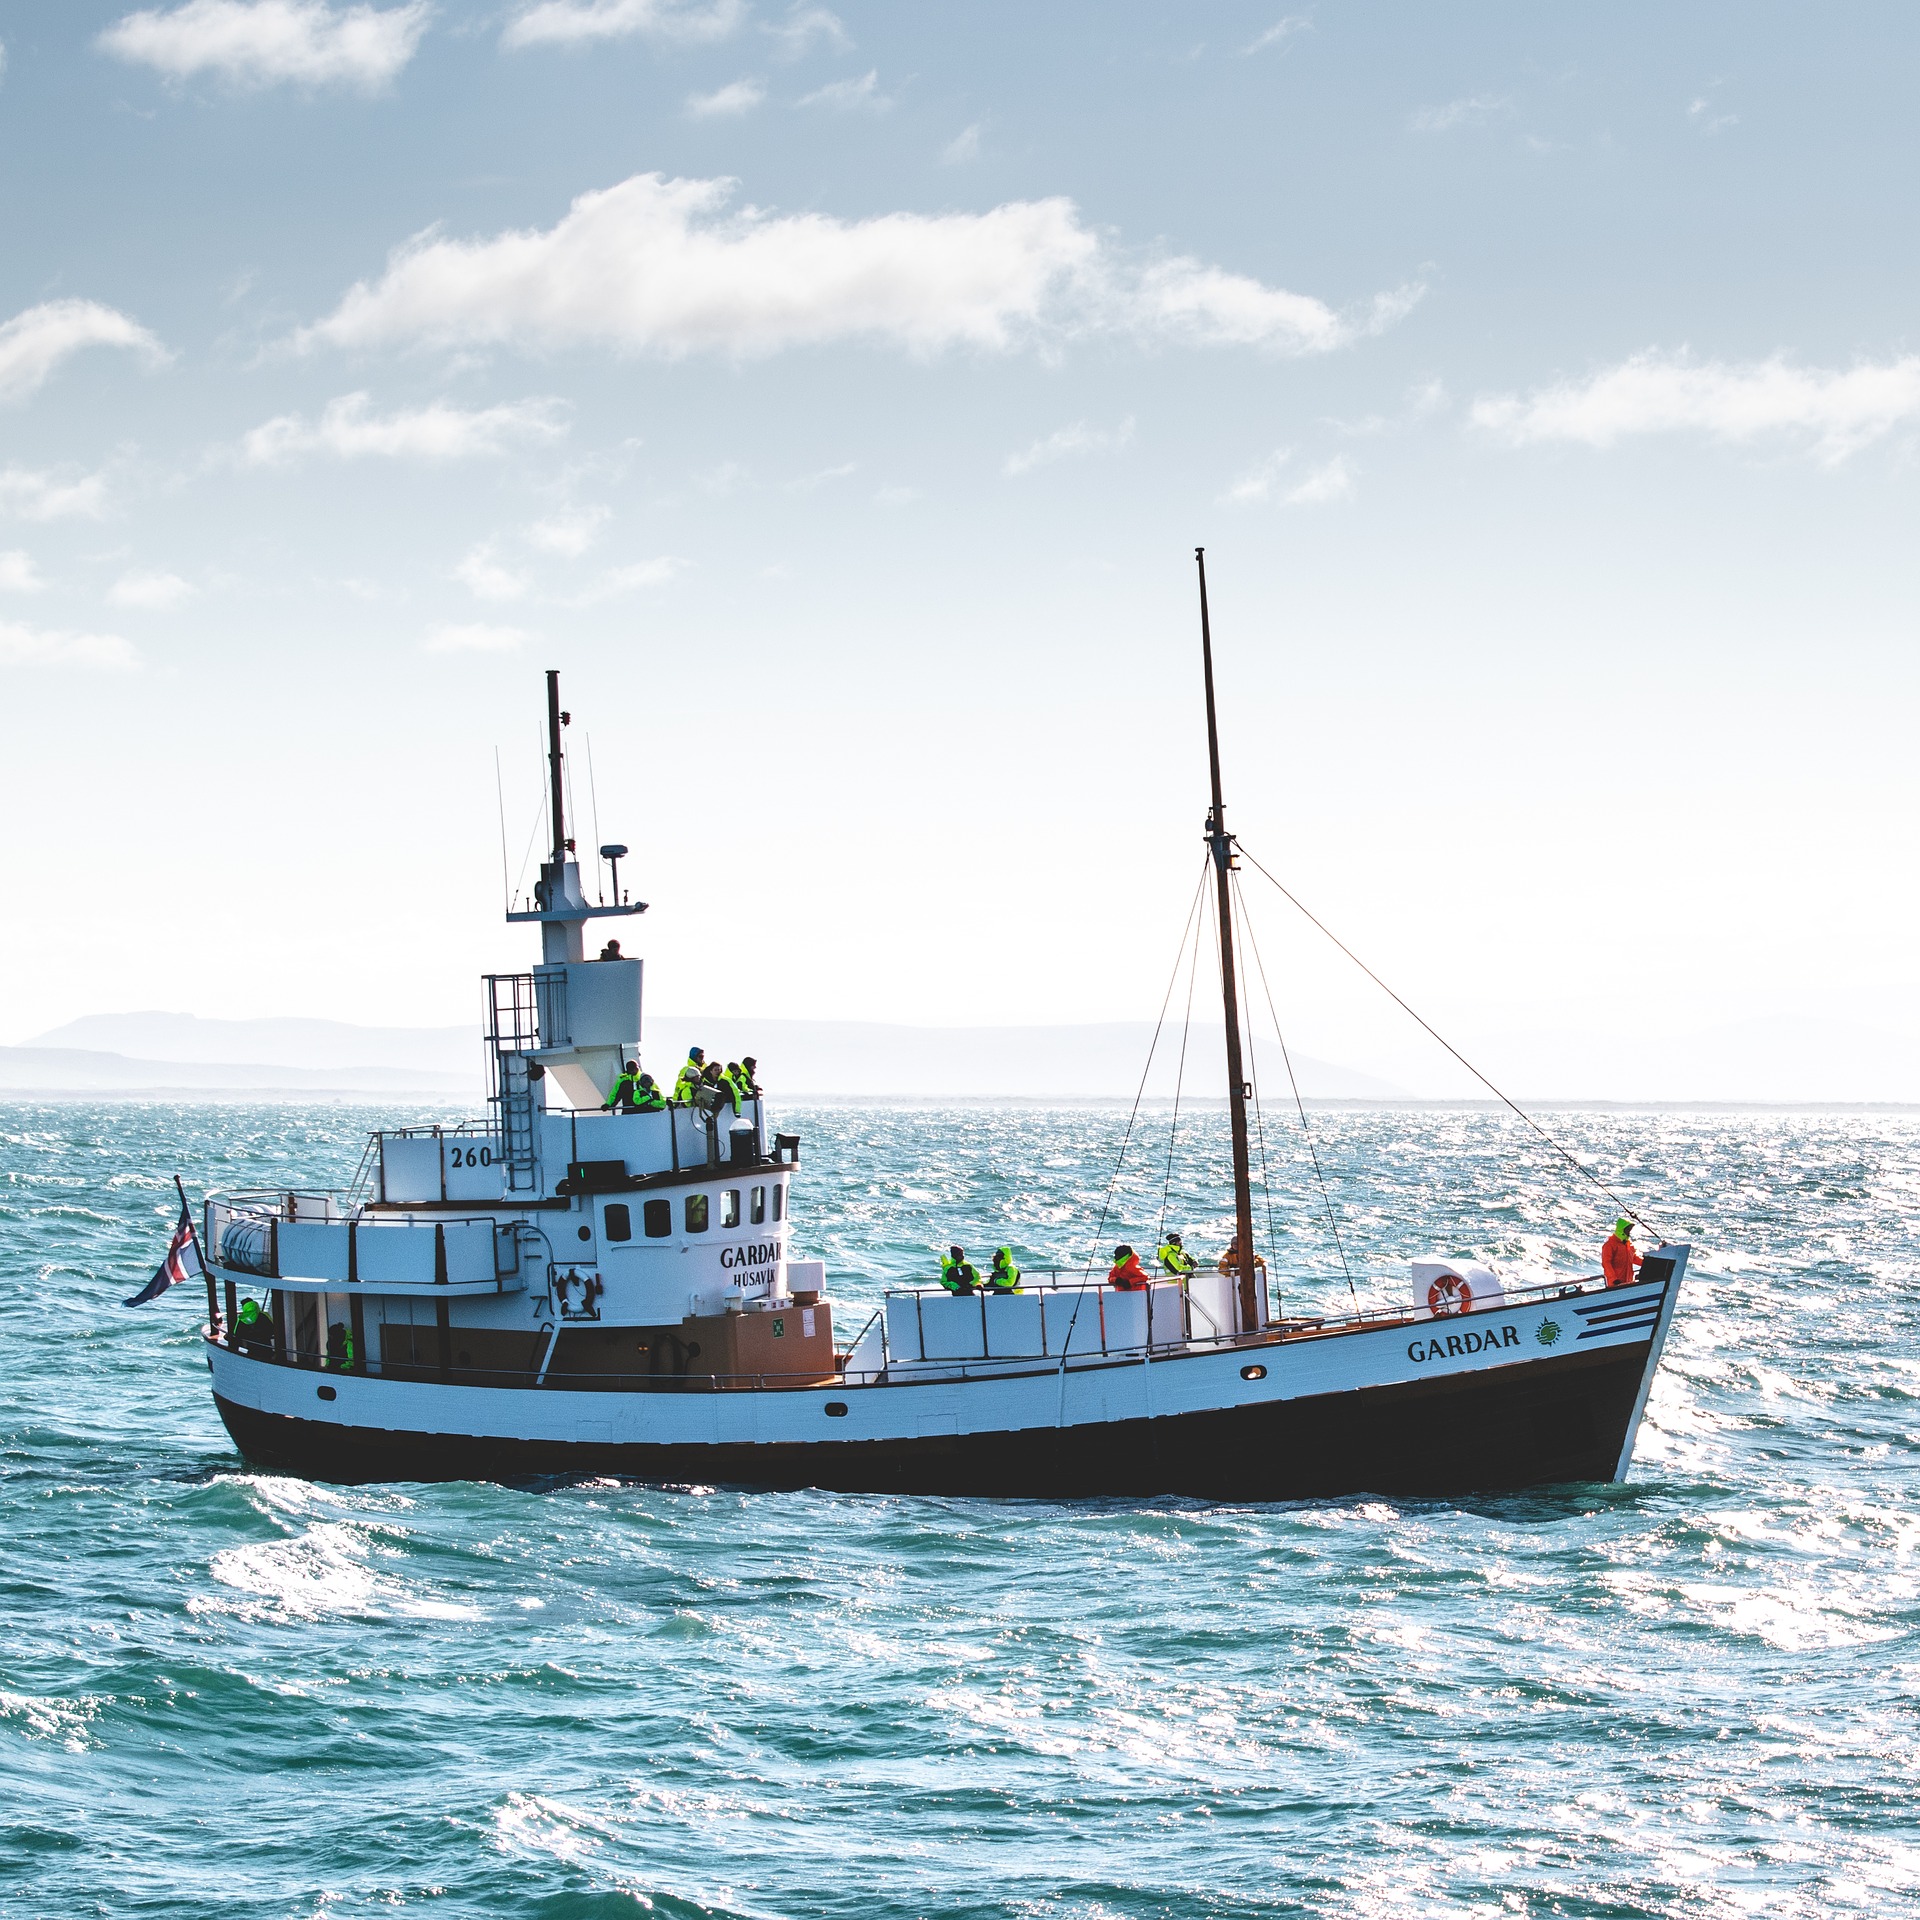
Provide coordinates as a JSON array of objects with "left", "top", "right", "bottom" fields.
[{"left": 0, "top": 1102, "right": 1920, "bottom": 1920}]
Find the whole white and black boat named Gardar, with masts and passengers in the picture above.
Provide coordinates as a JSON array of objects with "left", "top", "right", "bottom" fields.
[{"left": 176, "top": 555, "right": 1688, "bottom": 1500}]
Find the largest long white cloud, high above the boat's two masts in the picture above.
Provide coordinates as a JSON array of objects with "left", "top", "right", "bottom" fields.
[{"left": 300, "top": 173, "right": 1421, "bottom": 359}]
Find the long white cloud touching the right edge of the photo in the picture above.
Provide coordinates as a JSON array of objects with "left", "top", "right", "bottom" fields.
[{"left": 1473, "top": 353, "right": 1920, "bottom": 467}]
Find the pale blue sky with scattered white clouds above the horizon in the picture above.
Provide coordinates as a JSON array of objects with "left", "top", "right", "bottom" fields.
[{"left": 0, "top": 0, "right": 1920, "bottom": 1098}]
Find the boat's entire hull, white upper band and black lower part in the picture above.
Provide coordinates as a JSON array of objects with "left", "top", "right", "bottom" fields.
[{"left": 215, "top": 1275, "right": 1678, "bottom": 1501}]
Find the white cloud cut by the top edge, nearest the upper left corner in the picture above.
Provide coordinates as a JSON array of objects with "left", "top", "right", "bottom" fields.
[{"left": 98, "top": 0, "right": 432, "bottom": 92}]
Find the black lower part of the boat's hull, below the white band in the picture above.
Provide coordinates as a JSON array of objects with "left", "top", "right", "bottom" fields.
[{"left": 215, "top": 1344, "right": 1649, "bottom": 1501}]
